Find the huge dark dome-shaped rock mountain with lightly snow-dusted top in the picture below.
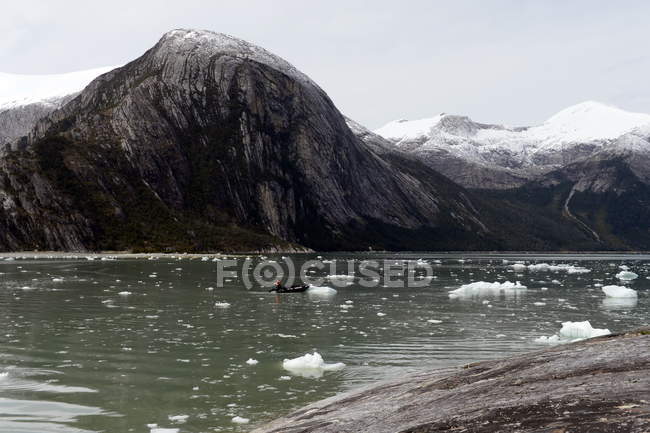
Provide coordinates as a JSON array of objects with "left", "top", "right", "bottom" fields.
[{"left": 0, "top": 30, "right": 505, "bottom": 251}]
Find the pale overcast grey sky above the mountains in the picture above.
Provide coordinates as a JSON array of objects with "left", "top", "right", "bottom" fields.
[{"left": 0, "top": 0, "right": 650, "bottom": 129}]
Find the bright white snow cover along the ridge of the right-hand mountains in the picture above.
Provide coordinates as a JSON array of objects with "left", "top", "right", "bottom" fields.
[{"left": 374, "top": 101, "right": 650, "bottom": 169}]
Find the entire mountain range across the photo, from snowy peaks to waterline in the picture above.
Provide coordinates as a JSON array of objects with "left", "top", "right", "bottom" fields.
[{"left": 0, "top": 30, "right": 650, "bottom": 251}]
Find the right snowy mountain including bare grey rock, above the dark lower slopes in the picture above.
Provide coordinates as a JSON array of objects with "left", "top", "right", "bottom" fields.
[{"left": 375, "top": 101, "right": 650, "bottom": 188}]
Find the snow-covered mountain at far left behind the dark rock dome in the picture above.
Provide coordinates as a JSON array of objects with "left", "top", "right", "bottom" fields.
[{"left": 0, "top": 66, "right": 115, "bottom": 145}]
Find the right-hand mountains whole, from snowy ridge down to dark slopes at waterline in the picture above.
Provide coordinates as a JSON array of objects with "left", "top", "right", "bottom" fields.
[{"left": 375, "top": 102, "right": 650, "bottom": 250}]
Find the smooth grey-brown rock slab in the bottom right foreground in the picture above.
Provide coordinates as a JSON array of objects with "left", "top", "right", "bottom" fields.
[{"left": 254, "top": 330, "right": 650, "bottom": 433}]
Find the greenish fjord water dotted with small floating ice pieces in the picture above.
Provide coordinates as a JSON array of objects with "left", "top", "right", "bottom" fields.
[{"left": 0, "top": 253, "right": 650, "bottom": 433}]
